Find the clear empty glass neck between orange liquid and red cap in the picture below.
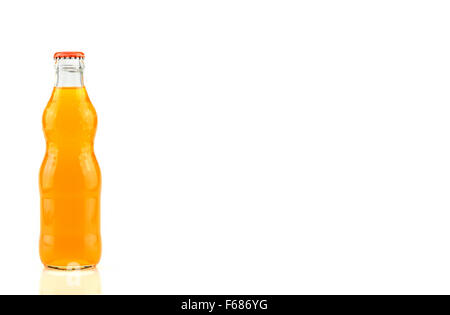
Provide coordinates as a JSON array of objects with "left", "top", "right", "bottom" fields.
[{"left": 55, "top": 58, "right": 84, "bottom": 87}]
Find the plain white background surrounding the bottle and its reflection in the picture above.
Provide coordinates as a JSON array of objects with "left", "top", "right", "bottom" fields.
[{"left": 0, "top": 0, "right": 450, "bottom": 294}]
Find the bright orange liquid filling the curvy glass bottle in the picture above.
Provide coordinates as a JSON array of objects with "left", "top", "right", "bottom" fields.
[{"left": 39, "top": 87, "right": 101, "bottom": 269}]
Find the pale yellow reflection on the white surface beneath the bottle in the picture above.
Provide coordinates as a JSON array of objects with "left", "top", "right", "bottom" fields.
[{"left": 40, "top": 269, "right": 102, "bottom": 295}]
